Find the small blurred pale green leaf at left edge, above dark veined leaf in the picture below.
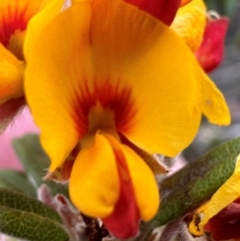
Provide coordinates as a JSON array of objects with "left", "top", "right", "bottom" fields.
[{"left": 0, "top": 169, "right": 37, "bottom": 197}]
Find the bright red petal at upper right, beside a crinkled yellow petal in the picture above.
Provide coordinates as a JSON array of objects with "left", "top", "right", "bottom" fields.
[{"left": 195, "top": 18, "right": 229, "bottom": 72}]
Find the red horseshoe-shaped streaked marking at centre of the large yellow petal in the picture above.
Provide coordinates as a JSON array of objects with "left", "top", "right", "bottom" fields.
[{"left": 73, "top": 81, "right": 136, "bottom": 135}]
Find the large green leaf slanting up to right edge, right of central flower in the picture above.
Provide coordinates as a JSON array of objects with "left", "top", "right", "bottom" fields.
[{"left": 151, "top": 138, "right": 240, "bottom": 226}]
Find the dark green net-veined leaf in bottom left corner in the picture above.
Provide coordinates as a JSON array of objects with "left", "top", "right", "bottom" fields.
[{"left": 0, "top": 188, "right": 69, "bottom": 241}]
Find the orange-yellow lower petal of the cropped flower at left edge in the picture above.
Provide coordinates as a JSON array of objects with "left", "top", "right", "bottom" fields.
[{"left": 0, "top": 43, "right": 24, "bottom": 104}]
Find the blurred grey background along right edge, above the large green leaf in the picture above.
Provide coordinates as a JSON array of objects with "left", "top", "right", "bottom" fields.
[{"left": 183, "top": 0, "right": 240, "bottom": 161}]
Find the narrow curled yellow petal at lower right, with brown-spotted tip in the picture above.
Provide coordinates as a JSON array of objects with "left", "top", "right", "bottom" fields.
[{"left": 190, "top": 155, "right": 240, "bottom": 235}]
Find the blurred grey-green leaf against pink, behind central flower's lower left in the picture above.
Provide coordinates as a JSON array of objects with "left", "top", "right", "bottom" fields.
[{"left": 12, "top": 134, "right": 68, "bottom": 197}]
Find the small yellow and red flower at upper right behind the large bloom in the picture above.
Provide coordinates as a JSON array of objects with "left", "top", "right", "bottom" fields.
[{"left": 171, "top": 0, "right": 229, "bottom": 72}]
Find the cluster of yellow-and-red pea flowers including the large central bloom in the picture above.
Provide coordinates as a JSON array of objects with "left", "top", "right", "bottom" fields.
[{"left": 0, "top": 0, "right": 230, "bottom": 239}]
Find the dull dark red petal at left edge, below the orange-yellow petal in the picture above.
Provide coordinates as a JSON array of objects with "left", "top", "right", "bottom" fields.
[{"left": 0, "top": 97, "right": 26, "bottom": 133}]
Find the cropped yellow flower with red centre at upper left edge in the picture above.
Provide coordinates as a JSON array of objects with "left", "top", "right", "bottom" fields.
[{"left": 0, "top": 0, "right": 64, "bottom": 132}]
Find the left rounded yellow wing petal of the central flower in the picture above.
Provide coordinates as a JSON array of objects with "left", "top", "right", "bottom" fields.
[{"left": 69, "top": 133, "right": 120, "bottom": 217}]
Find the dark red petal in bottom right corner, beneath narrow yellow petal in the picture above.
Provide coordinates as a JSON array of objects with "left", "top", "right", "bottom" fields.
[{"left": 204, "top": 200, "right": 240, "bottom": 241}]
